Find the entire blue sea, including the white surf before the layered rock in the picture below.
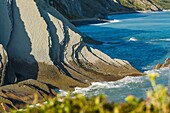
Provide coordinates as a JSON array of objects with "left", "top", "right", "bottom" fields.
[{"left": 73, "top": 12, "right": 170, "bottom": 102}]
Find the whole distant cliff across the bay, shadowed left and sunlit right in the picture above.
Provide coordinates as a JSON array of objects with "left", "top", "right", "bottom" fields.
[{"left": 50, "top": 0, "right": 170, "bottom": 19}]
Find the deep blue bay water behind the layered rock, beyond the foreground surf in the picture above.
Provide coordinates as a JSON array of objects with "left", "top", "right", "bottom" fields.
[{"left": 78, "top": 12, "right": 170, "bottom": 71}]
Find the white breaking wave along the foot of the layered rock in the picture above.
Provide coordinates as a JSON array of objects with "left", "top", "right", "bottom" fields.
[{"left": 73, "top": 68, "right": 170, "bottom": 95}]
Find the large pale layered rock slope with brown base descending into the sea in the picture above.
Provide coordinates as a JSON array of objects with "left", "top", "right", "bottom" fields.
[{"left": 0, "top": 0, "right": 142, "bottom": 109}]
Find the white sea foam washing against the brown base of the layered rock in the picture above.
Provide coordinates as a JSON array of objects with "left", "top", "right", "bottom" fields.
[{"left": 73, "top": 68, "right": 170, "bottom": 96}]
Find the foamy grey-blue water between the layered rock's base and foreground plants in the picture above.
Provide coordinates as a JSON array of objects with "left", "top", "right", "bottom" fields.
[{"left": 73, "top": 68, "right": 170, "bottom": 102}]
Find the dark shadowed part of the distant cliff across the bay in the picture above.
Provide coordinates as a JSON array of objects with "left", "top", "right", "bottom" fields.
[{"left": 51, "top": 0, "right": 131, "bottom": 19}]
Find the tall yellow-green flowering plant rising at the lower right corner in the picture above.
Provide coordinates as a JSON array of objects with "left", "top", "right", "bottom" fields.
[{"left": 146, "top": 73, "right": 170, "bottom": 113}]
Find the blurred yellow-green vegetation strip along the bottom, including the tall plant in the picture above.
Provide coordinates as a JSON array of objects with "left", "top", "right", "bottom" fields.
[{"left": 8, "top": 74, "right": 170, "bottom": 113}]
